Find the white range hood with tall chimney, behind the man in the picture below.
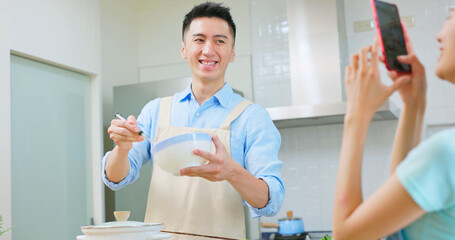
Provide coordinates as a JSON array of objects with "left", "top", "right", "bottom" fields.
[{"left": 258, "top": 0, "right": 400, "bottom": 128}]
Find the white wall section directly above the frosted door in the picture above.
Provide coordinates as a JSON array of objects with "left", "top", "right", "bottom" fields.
[{"left": 11, "top": 0, "right": 100, "bottom": 74}]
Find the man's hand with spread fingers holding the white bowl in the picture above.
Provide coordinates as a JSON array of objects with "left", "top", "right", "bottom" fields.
[{"left": 180, "top": 135, "right": 240, "bottom": 182}]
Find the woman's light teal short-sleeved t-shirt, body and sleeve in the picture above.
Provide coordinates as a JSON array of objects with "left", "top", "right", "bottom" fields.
[{"left": 396, "top": 128, "right": 455, "bottom": 240}]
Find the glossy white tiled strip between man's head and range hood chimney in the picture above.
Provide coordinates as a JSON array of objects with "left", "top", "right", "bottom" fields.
[{"left": 250, "top": 0, "right": 292, "bottom": 107}]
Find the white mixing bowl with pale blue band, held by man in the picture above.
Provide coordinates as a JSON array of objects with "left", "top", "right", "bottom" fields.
[{"left": 151, "top": 132, "right": 212, "bottom": 176}]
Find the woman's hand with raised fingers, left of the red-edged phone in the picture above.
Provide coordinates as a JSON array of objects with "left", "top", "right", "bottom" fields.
[{"left": 345, "top": 39, "right": 411, "bottom": 120}]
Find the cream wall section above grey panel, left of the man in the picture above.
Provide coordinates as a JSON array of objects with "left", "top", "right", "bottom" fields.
[{"left": 100, "top": 0, "right": 139, "bottom": 142}]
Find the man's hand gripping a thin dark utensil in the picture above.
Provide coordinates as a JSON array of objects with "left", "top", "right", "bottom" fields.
[{"left": 107, "top": 115, "right": 144, "bottom": 151}]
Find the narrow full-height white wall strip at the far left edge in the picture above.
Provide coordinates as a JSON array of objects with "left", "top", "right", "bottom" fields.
[{"left": 0, "top": 0, "right": 11, "bottom": 240}]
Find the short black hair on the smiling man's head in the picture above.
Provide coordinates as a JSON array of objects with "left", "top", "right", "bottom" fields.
[{"left": 182, "top": 2, "right": 239, "bottom": 42}]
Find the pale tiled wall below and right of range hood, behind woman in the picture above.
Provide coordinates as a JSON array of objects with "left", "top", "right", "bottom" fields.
[{"left": 261, "top": 0, "right": 455, "bottom": 231}]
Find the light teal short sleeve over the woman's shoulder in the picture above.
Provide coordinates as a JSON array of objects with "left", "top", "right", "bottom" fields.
[{"left": 396, "top": 128, "right": 455, "bottom": 212}]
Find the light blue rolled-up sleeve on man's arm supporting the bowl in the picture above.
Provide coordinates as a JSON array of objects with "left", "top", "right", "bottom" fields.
[{"left": 239, "top": 104, "right": 285, "bottom": 217}]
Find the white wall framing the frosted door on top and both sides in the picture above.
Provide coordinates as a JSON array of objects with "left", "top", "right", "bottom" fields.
[{"left": 0, "top": 0, "right": 104, "bottom": 239}]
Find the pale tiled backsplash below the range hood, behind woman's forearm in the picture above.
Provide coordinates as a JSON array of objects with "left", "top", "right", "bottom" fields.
[{"left": 261, "top": 120, "right": 397, "bottom": 231}]
